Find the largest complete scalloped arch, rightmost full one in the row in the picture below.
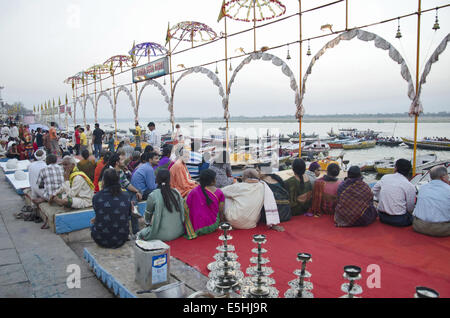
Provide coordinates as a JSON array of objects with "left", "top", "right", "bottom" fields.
[{"left": 300, "top": 30, "right": 419, "bottom": 116}]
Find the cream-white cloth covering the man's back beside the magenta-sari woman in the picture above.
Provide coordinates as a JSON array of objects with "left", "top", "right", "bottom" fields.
[{"left": 221, "top": 182, "right": 265, "bottom": 229}]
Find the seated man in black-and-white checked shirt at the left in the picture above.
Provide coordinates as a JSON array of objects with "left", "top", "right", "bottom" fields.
[{"left": 33, "top": 154, "right": 64, "bottom": 204}]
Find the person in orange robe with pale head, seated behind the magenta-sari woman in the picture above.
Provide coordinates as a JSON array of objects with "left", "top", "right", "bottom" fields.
[{"left": 170, "top": 148, "right": 198, "bottom": 198}]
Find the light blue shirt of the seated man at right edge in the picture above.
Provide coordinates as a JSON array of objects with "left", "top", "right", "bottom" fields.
[{"left": 413, "top": 180, "right": 450, "bottom": 223}]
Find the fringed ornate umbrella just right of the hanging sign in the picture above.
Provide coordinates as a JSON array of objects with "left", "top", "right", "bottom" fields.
[{"left": 169, "top": 21, "right": 217, "bottom": 46}]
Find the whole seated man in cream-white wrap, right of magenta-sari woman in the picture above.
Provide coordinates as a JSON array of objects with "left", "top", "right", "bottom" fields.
[{"left": 221, "top": 168, "right": 284, "bottom": 231}]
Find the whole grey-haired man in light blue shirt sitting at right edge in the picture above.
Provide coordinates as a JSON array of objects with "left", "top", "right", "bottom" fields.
[{"left": 413, "top": 166, "right": 450, "bottom": 236}]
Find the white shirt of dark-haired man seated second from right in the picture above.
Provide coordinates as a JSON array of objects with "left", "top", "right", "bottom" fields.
[{"left": 372, "top": 172, "right": 416, "bottom": 215}]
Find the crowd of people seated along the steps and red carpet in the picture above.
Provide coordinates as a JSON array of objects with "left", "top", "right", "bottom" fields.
[{"left": 7, "top": 120, "right": 450, "bottom": 248}]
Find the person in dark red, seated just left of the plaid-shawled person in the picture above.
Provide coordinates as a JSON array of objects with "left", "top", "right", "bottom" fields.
[{"left": 311, "top": 163, "right": 342, "bottom": 217}]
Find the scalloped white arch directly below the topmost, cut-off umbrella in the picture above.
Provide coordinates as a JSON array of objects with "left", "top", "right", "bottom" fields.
[{"left": 222, "top": 52, "right": 298, "bottom": 119}]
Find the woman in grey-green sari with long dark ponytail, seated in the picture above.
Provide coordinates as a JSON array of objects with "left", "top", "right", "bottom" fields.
[{"left": 137, "top": 169, "right": 185, "bottom": 241}]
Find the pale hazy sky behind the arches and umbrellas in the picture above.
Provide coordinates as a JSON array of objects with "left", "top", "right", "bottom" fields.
[{"left": 0, "top": 0, "right": 450, "bottom": 119}]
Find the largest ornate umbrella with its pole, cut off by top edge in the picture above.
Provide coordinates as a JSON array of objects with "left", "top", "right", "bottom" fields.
[{"left": 222, "top": 0, "right": 286, "bottom": 51}]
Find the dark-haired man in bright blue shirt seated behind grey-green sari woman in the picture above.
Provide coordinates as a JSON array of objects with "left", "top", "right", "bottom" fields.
[{"left": 131, "top": 152, "right": 159, "bottom": 200}]
